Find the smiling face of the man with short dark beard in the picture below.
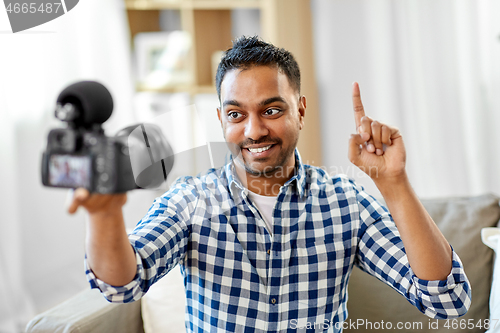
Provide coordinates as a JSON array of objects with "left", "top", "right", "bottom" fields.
[{"left": 217, "top": 66, "right": 305, "bottom": 176}]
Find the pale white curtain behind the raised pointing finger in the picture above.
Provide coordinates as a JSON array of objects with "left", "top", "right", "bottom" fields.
[{"left": 312, "top": 0, "right": 500, "bottom": 197}]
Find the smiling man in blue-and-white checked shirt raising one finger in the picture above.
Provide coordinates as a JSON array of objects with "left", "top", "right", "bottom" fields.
[{"left": 69, "top": 37, "right": 470, "bottom": 332}]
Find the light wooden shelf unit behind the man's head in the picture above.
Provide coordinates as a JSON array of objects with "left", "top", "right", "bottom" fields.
[{"left": 125, "top": 0, "right": 322, "bottom": 165}]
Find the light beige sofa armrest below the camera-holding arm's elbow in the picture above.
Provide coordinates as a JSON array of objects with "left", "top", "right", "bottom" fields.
[{"left": 26, "top": 289, "right": 144, "bottom": 333}]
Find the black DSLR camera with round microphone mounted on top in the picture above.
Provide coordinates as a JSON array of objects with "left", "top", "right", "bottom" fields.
[{"left": 41, "top": 81, "right": 174, "bottom": 193}]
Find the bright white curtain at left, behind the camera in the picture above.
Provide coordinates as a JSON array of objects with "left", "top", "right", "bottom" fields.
[{"left": 0, "top": 0, "right": 134, "bottom": 332}]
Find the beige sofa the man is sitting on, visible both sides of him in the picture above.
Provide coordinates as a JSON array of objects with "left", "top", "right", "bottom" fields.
[{"left": 26, "top": 194, "right": 500, "bottom": 333}]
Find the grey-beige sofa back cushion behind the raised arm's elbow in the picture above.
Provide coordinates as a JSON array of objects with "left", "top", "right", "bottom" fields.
[{"left": 344, "top": 195, "right": 500, "bottom": 333}]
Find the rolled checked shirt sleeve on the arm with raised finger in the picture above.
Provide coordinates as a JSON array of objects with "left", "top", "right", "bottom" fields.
[{"left": 355, "top": 185, "right": 471, "bottom": 319}]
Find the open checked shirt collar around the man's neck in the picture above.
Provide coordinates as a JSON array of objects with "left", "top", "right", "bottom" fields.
[{"left": 224, "top": 148, "right": 306, "bottom": 202}]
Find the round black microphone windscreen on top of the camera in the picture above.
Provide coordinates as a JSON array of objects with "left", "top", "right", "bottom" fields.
[{"left": 57, "top": 81, "right": 113, "bottom": 126}]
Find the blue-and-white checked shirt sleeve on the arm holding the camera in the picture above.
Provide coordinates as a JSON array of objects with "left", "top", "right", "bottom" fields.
[{"left": 85, "top": 181, "right": 197, "bottom": 303}]
